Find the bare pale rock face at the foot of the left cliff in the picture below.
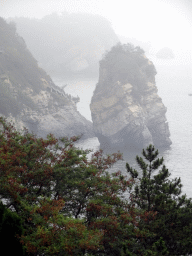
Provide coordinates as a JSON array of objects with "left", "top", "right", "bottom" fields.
[{"left": 3, "top": 87, "right": 95, "bottom": 139}]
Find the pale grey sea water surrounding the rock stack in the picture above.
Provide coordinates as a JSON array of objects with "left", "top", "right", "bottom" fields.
[{"left": 53, "top": 57, "right": 192, "bottom": 197}]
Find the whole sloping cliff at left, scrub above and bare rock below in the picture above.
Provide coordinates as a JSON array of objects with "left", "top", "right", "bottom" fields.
[{"left": 0, "top": 18, "right": 94, "bottom": 138}]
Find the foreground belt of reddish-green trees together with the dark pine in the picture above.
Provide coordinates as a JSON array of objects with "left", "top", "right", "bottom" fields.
[{"left": 0, "top": 118, "right": 192, "bottom": 256}]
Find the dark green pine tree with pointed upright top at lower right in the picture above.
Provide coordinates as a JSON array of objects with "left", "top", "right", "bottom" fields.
[{"left": 126, "top": 145, "right": 192, "bottom": 255}]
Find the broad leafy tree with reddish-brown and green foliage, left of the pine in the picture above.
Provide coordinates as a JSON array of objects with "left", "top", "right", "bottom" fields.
[{"left": 0, "top": 118, "right": 140, "bottom": 255}]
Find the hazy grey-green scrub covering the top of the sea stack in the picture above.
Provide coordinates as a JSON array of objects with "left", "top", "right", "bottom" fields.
[{"left": 100, "top": 43, "right": 157, "bottom": 89}]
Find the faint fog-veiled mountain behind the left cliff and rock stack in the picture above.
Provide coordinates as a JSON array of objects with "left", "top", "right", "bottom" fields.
[{"left": 11, "top": 12, "right": 119, "bottom": 76}]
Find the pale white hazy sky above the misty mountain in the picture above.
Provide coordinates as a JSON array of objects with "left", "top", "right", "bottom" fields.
[{"left": 0, "top": 0, "right": 192, "bottom": 57}]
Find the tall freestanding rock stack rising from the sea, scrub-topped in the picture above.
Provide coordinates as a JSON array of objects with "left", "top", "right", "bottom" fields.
[{"left": 90, "top": 44, "right": 171, "bottom": 149}]
